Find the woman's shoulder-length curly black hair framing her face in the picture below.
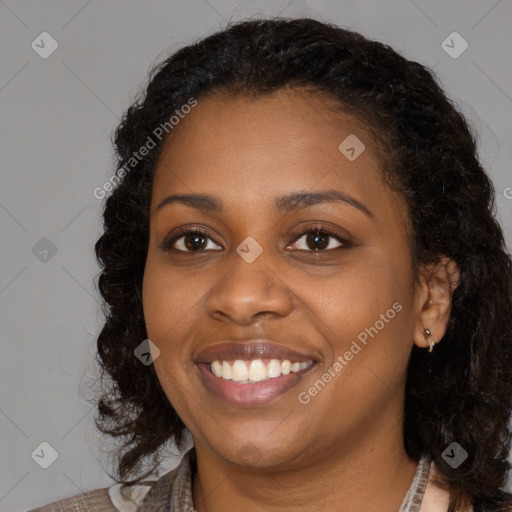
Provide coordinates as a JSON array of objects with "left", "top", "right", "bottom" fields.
[{"left": 95, "top": 18, "right": 512, "bottom": 511}]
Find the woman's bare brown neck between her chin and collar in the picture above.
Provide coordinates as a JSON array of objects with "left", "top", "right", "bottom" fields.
[{"left": 193, "top": 414, "right": 418, "bottom": 512}]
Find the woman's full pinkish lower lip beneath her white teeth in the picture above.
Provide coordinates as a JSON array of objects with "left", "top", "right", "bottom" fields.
[{"left": 197, "top": 363, "right": 315, "bottom": 407}]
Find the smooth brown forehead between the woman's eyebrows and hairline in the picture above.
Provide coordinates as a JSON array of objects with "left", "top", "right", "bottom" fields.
[{"left": 153, "top": 89, "right": 390, "bottom": 214}]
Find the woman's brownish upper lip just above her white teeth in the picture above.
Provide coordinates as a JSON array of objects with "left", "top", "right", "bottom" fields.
[{"left": 194, "top": 338, "right": 316, "bottom": 363}]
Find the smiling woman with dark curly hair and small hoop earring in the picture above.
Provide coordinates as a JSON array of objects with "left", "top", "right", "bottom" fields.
[{"left": 32, "top": 19, "right": 512, "bottom": 512}]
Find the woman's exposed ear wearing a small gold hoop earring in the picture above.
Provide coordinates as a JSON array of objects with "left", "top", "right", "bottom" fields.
[{"left": 414, "top": 256, "right": 460, "bottom": 348}]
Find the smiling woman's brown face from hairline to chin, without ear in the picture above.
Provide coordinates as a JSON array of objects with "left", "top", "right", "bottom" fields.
[{"left": 141, "top": 90, "right": 421, "bottom": 467}]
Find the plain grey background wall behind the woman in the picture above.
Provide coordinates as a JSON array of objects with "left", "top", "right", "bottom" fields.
[{"left": 0, "top": 0, "right": 512, "bottom": 511}]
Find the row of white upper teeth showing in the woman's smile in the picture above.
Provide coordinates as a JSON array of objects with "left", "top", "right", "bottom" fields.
[{"left": 211, "top": 359, "right": 313, "bottom": 383}]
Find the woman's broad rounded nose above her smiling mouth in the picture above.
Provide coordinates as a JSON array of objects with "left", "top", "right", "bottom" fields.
[{"left": 206, "top": 247, "right": 293, "bottom": 325}]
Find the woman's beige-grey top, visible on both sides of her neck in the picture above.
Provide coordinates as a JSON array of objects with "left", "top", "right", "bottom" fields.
[{"left": 30, "top": 448, "right": 466, "bottom": 512}]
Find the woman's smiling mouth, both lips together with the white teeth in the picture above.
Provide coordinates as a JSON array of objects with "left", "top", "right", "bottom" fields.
[{"left": 195, "top": 340, "right": 317, "bottom": 407}]
